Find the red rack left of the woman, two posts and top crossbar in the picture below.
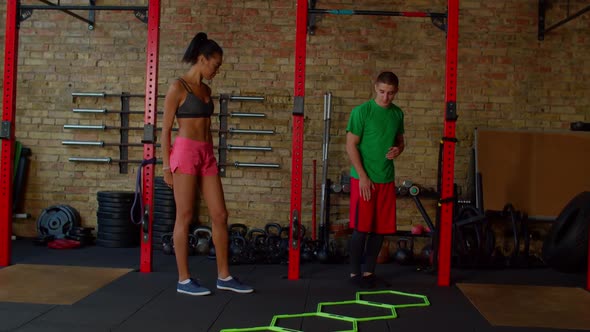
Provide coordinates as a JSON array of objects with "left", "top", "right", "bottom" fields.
[{"left": 0, "top": 0, "right": 160, "bottom": 272}]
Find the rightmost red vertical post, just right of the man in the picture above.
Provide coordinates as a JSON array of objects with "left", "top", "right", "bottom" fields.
[{"left": 438, "top": 0, "right": 459, "bottom": 286}]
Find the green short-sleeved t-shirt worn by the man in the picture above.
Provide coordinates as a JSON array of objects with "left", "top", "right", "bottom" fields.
[{"left": 346, "top": 100, "right": 404, "bottom": 183}]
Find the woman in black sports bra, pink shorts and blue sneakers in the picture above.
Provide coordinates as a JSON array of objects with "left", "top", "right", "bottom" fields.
[{"left": 162, "top": 32, "right": 254, "bottom": 295}]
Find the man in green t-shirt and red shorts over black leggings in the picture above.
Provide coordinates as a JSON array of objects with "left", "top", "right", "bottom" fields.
[{"left": 346, "top": 72, "right": 405, "bottom": 287}]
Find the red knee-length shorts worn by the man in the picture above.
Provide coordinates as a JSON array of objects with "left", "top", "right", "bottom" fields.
[{"left": 350, "top": 178, "right": 397, "bottom": 234}]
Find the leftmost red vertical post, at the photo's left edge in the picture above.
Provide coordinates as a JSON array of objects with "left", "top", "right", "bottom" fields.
[{"left": 0, "top": 0, "right": 19, "bottom": 266}]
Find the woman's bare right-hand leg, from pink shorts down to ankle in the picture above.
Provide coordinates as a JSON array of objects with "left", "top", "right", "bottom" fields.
[{"left": 199, "top": 175, "right": 230, "bottom": 279}]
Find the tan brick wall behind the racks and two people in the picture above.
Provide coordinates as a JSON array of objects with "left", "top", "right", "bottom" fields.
[{"left": 0, "top": 0, "right": 590, "bottom": 236}]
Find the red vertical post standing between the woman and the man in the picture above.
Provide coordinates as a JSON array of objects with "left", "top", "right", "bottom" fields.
[{"left": 288, "top": 0, "right": 307, "bottom": 280}]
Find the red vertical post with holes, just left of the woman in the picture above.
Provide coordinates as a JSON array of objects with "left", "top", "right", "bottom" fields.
[{"left": 139, "top": 0, "right": 160, "bottom": 272}]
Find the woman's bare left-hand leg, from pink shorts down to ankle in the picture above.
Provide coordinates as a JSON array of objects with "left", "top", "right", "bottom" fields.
[{"left": 173, "top": 172, "right": 197, "bottom": 281}]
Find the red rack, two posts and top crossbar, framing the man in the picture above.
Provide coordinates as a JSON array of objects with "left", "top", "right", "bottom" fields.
[{"left": 288, "top": 0, "right": 459, "bottom": 286}]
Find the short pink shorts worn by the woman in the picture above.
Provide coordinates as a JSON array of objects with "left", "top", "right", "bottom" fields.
[{"left": 170, "top": 136, "right": 219, "bottom": 176}]
